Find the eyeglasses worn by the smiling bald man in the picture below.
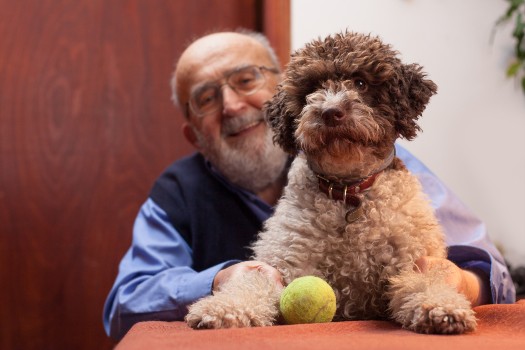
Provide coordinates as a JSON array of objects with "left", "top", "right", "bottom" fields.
[{"left": 187, "top": 66, "right": 279, "bottom": 117}]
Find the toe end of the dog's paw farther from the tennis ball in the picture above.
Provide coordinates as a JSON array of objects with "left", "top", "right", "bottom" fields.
[{"left": 405, "top": 304, "right": 477, "bottom": 334}]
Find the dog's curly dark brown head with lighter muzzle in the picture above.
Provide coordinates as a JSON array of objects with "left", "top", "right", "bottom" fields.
[{"left": 265, "top": 32, "right": 437, "bottom": 162}]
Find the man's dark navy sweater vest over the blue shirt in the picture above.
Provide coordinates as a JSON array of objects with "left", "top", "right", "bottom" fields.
[{"left": 150, "top": 153, "right": 262, "bottom": 271}]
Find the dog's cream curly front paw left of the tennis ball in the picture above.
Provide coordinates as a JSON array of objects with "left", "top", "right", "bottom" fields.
[{"left": 185, "top": 270, "right": 282, "bottom": 328}]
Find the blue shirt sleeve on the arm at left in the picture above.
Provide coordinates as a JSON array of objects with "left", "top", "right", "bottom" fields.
[{"left": 103, "top": 199, "right": 237, "bottom": 340}]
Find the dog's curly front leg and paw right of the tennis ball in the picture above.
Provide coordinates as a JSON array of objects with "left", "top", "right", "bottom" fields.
[{"left": 389, "top": 270, "right": 476, "bottom": 334}]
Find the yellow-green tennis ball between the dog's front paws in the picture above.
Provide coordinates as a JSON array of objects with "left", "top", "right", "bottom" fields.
[{"left": 279, "top": 276, "right": 336, "bottom": 324}]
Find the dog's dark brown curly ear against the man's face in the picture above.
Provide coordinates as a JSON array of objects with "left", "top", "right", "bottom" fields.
[{"left": 263, "top": 85, "right": 298, "bottom": 155}]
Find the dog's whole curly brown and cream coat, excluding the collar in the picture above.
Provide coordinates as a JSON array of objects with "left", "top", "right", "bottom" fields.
[{"left": 186, "top": 32, "right": 476, "bottom": 333}]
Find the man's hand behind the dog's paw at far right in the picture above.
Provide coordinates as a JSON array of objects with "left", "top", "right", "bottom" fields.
[{"left": 416, "top": 256, "right": 490, "bottom": 307}]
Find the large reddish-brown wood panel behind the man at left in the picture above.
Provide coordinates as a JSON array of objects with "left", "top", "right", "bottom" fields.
[{"left": 0, "top": 0, "right": 289, "bottom": 349}]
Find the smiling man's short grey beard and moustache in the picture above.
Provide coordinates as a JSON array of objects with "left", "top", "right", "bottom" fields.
[{"left": 194, "top": 111, "right": 288, "bottom": 193}]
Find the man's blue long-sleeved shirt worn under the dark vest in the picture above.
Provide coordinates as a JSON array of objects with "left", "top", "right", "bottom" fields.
[{"left": 103, "top": 145, "right": 515, "bottom": 339}]
